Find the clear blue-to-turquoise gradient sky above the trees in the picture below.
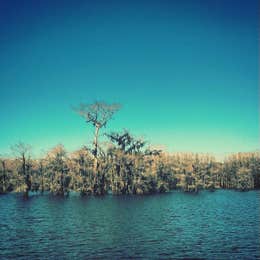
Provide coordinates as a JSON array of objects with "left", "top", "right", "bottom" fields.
[{"left": 0, "top": 0, "right": 260, "bottom": 156}]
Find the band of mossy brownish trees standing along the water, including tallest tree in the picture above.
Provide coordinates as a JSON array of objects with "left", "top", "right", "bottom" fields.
[{"left": 0, "top": 102, "right": 260, "bottom": 197}]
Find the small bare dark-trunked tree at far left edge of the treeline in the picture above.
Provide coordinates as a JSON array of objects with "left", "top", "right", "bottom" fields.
[{"left": 11, "top": 142, "right": 31, "bottom": 197}]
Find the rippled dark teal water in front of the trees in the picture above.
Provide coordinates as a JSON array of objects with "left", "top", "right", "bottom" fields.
[{"left": 0, "top": 190, "right": 260, "bottom": 259}]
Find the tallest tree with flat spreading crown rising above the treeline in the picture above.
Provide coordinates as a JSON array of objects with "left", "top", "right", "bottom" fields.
[{"left": 74, "top": 102, "right": 121, "bottom": 169}]
